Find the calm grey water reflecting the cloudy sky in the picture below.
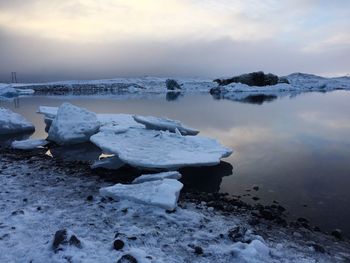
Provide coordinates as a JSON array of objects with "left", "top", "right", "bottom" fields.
[{"left": 0, "top": 91, "right": 350, "bottom": 236}]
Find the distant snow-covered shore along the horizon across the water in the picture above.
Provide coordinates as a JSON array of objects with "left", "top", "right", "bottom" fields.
[{"left": 0, "top": 73, "right": 350, "bottom": 98}]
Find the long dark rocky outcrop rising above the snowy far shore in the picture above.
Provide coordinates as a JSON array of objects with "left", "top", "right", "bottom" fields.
[{"left": 214, "top": 71, "right": 289, "bottom": 87}]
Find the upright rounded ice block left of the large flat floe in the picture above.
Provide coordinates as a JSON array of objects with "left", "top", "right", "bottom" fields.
[{"left": 48, "top": 103, "right": 100, "bottom": 145}]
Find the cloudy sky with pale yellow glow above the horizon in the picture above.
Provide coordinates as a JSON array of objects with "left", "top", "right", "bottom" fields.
[{"left": 0, "top": 0, "right": 350, "bottom": 82}]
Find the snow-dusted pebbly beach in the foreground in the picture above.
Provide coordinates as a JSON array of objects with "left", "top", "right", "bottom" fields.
[{"left": 0, "top": 151, "right": 350, "bottom": 263}]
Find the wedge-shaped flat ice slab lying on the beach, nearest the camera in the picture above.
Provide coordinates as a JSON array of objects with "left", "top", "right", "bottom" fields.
[{"left": 100, "top": 179, "right": 183, "bottom": 210}]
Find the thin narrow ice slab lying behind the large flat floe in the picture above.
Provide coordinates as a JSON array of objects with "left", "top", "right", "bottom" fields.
[{"left": 133, "top": 115, "right": 199, "bottom": 135}]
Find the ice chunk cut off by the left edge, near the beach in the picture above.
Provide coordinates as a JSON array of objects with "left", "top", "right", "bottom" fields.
[{"left": 0, "top": 108, "right": 35, "bottom": 134}]
